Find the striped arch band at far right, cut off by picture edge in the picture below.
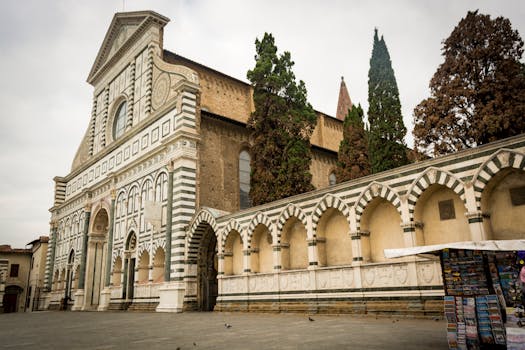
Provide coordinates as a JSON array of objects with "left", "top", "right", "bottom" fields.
[{"left": 472, "top": 148, "right": 525, "bottom": 210}]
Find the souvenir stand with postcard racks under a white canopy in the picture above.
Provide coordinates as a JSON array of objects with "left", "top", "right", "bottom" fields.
[{"left": 385, "top": 240, "right": 525, "bottom": 350}]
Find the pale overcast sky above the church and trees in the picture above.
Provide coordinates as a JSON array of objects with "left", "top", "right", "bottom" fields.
[{"left": 0, "top": 0, "right": 525, "bottom": 247}]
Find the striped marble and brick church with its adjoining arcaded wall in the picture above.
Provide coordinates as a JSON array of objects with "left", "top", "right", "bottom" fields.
[{"left": 45, "top": 11, "right": 525, "bottom": 315}]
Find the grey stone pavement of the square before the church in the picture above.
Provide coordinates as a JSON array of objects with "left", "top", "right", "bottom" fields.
[{"left": 0, "top": 312, "right": 448, "bottom": 350}]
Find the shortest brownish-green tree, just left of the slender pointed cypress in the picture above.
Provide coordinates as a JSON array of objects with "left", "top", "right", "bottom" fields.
[{"left": 335, "top": 104, "right": 371, "bottom": 182}]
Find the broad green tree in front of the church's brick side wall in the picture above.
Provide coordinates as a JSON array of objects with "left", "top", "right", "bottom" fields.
[{"left": 247, "top": 33, "right": 317, "bottom": 205}]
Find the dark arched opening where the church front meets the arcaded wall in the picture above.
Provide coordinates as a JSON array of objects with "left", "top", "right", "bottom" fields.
[{"left": 197, "top": 226, "right": 219, "bottom": 311}]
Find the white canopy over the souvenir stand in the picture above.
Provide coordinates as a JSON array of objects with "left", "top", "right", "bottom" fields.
[{"left": 385, "top": 239, "right": 525, "bottom": 259}]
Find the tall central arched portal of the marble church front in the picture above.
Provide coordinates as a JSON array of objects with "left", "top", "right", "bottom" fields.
[{"left": 86, "top": 208, "right": 109, "bottom": 309}]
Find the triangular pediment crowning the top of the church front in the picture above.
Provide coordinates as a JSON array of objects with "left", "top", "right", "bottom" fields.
[{"left": 87, "top": 11, "right": 169, "bottom": 83}]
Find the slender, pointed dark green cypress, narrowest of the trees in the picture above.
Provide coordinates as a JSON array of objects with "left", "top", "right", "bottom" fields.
[{"left": 368, "top": 29, "right": 408, "bottom": 173}]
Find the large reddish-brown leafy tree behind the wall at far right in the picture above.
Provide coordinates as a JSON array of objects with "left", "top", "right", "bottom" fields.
[{"left": 413, "top": 11, "right": 525, "bottom": 156}]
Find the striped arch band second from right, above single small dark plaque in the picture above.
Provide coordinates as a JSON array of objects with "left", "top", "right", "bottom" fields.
[{"left": 407, "top": 167, "right": 467, "bottom": 221}]
